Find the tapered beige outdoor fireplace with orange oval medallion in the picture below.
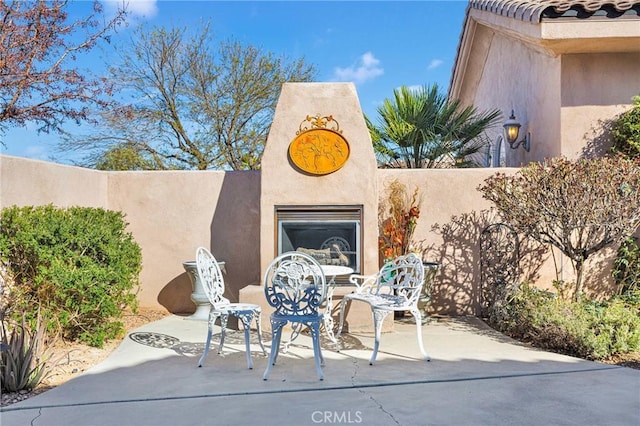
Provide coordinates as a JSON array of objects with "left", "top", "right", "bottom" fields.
[{"left": 248, "top": 83, "right": 379, "bottom": 330}]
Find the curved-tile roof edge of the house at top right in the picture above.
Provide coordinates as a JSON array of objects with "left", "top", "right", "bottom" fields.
[{"left": 469, "top": 0, "right": 640, "bottom": 24}]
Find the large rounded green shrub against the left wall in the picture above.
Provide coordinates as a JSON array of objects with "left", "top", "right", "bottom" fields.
[{"left": 0, "top": 205, "right": 142, "bottom": 347}]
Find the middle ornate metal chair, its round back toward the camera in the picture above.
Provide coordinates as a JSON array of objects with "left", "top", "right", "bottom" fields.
[{"left": 263, "top": 252, "right": 327, "bottom": 380}]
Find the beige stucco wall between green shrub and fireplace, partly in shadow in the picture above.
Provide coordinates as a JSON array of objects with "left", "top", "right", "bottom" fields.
[{"left": 109, "top": 171, "right": 260, "bottom": 312}]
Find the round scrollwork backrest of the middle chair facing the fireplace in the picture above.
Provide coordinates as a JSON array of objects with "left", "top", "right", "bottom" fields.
[{"left": 264, "top": 252, "right": 327, "bottom": 316}]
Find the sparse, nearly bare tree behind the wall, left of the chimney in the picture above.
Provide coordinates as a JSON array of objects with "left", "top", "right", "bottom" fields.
[{"left": 62, "top": 25, "right": 315, "bottom": 170}]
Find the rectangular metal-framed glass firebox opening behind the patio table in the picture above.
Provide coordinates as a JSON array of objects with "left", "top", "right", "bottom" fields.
[{"left": 276, "top": 206, "right": 362, "bottom": 273}]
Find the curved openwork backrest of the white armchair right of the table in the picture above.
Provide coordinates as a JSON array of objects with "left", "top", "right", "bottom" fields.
[{"left": 373, "top": 253, "right": 424, "bottom": 306}]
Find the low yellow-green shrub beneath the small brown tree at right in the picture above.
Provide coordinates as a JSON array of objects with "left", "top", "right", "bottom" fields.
[{"left": 493, "top": 285, "right": 640, "bottom": 360}]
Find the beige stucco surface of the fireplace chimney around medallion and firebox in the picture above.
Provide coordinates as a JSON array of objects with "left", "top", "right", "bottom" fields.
[{"left": 260, "top": 83, "right": 378, "bottom": 274}]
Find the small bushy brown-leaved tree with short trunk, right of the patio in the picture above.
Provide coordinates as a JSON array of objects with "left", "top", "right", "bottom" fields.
[{"left": 478, "top": 156, "right": 640, "bottom": 297}]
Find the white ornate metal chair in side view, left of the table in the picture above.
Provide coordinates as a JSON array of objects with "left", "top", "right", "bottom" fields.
[{"left": 196, "top": 247, "right": 267, "bottom": 369}]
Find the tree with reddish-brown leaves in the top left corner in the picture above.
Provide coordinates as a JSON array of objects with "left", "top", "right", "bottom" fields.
[{"left": 0, "top": 0, "right": 125, "bottom": 141}]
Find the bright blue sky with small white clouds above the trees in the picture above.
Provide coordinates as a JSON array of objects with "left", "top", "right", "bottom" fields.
[{"left": 1, "top": 0, "right": 467, "bottom": 162}]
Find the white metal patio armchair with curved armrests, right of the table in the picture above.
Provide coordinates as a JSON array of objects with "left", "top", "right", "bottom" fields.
[{"left": 337, "top": 253, "right": 431, "bottom": 365}]
